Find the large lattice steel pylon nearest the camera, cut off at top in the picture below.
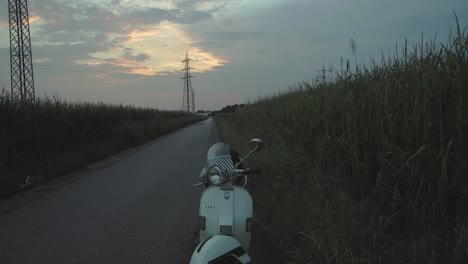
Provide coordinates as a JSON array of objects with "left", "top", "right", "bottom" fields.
[{"left": 8, "top": 0, "right": 35, "bottom": 101}]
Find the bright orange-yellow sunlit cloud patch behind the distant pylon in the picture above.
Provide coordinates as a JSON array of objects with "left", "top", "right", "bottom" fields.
[{"left": 77, "top": 22, "right": 228, "bottom": 75}]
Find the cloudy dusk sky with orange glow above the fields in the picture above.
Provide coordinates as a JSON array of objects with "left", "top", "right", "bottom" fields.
[{"left": 0, "top": 0, "right": 468, "bottom": 110}]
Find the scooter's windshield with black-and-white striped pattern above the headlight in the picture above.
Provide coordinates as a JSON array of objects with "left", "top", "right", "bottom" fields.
[{"left": 200, "top": 143, "right": 234, "bottom": 182}]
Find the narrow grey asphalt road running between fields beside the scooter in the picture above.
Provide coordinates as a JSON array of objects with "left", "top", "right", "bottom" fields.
[{"left": 0, "top": 119, "right": 219, "bottom": 264}]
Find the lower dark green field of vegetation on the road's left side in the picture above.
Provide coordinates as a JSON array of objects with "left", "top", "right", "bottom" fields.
[{"left": 0, "top": 94, "right": 205, "bottom": 197}]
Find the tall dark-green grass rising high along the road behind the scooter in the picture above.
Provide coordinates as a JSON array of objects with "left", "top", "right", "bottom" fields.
[{"left": 216, "top": 21, "right": 468, "bottom": 263}]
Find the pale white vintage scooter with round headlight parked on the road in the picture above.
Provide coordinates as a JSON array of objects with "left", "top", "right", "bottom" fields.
[{"left": 190, "top": 138, "right": 263, "bottom": 264}]
